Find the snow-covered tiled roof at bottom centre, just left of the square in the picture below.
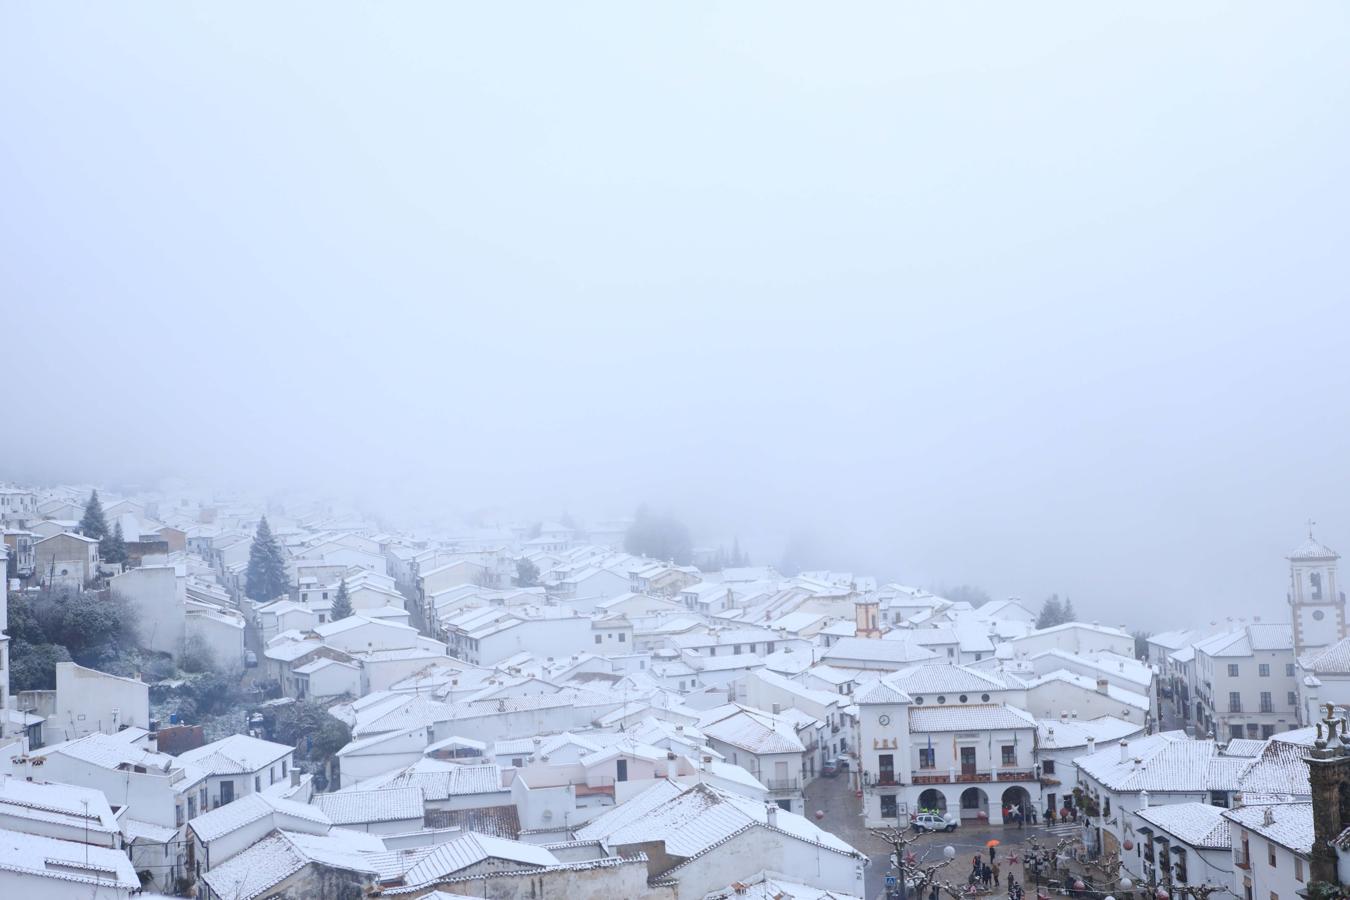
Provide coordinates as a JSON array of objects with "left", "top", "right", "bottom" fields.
[{"left": 575, "top": 781, "right": 861, "bottom": 861}]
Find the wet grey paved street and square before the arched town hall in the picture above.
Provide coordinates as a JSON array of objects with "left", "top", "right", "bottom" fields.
[{"left": 805, "top": 776, "right": 1079, "bottom": 900}]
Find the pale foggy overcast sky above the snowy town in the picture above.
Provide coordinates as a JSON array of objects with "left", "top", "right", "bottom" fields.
[{"left": 0, "top": 1, "right": 1350, "bottom": 627}]
